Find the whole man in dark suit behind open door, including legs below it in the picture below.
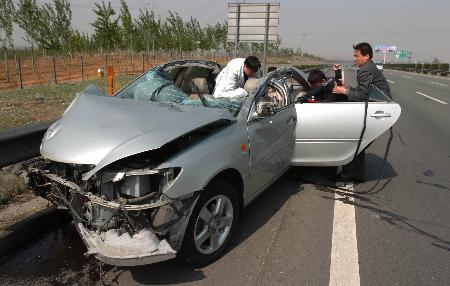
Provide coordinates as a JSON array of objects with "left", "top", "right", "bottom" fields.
[{"left": 333, "top": 43, "right": 392, "bottom": 182}]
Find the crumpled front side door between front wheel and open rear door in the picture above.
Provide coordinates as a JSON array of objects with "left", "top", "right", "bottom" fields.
[{"left": 247, "top": 78, "right": 297, "bottom": 197}]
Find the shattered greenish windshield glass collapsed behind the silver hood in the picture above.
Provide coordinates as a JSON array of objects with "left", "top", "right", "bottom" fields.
[{"left": 115, "top": 67, "right": 245, "bottom": 115}]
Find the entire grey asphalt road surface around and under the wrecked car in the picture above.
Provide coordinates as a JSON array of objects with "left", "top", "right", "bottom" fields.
[{"left": 0, "top": 70, "right": 450, "bottom": 285}]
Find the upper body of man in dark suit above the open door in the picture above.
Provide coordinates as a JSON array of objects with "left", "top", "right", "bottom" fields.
[{"left": 333, "top": 43, "right": 392, "bottom": 101}]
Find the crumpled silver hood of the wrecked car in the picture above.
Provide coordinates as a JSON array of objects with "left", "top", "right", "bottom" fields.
[{"left": 41, "top": 92, "right": 235, "bottom": 173}]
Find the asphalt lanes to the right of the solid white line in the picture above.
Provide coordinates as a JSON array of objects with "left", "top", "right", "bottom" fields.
[{"left": 347, "top": 70, "right": 450, "bottom": 285}]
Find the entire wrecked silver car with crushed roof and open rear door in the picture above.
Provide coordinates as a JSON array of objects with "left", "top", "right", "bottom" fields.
[{"left": 29, "top": 61, "right": 400, "bottom": 266}]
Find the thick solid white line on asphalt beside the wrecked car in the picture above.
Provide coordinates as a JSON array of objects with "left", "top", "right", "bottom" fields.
[{"left": 329, "top": 184, "right": 360, "bottom": 286}]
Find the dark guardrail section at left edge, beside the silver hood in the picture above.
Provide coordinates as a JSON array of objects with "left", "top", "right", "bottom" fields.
[{"left": 0, "top": 120, "right": 56, "bottom": 168}]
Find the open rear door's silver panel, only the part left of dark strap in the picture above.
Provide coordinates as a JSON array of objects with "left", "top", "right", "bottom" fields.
[{"left": 292, "top": 102, "right": 364, "bottom": 166}]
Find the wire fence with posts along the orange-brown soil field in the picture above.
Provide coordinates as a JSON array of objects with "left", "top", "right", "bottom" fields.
[{"left": 0, "top": 51, "right": 230, "bottom": 90}]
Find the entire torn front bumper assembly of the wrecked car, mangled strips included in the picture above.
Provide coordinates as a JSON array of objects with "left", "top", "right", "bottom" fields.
[{"left": 25, "top": 161, "right": 199, "bottom": 266}]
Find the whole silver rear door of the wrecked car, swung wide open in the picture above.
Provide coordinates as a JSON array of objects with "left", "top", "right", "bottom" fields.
[{"left": 292, "top": 86, "right": 401, "bottom": 166}]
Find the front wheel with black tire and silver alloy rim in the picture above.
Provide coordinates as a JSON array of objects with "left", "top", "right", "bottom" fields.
[{"left": 180, "top": 179, "right": 240, "bottom": 266}]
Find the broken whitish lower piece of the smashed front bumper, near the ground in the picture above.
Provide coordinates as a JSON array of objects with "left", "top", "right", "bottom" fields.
[{"left": 76, "top": 223, "right": 177, "bottom": 266}]
